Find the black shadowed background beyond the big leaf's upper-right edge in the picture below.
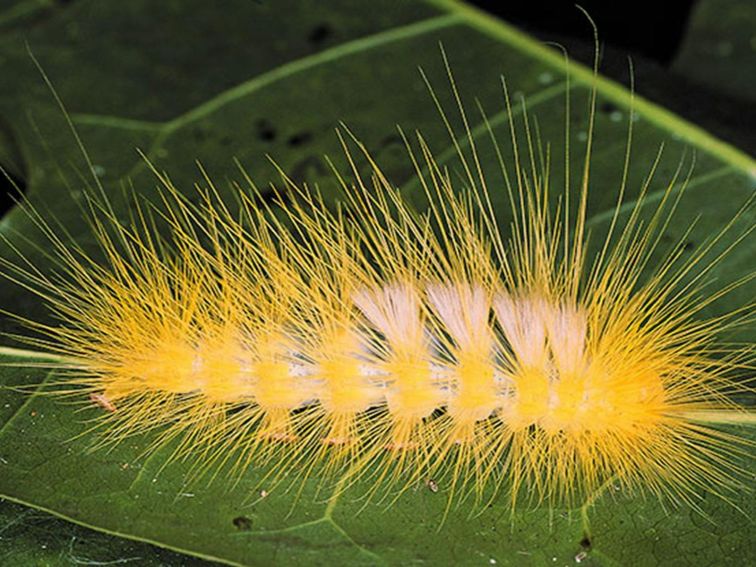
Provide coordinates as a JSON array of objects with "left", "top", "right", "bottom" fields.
[{"left": 468, "top": 0, "right": 756, "bottom": 155}]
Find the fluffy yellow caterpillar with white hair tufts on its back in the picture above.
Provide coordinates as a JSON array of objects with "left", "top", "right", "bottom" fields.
[{"left": 0, "top": 45, "right": 752, "bottom": 520}]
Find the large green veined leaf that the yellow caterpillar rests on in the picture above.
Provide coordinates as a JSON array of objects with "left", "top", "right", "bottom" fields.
[{"left": 0, "top": 0, "right": 756, "bottom": 565}]
